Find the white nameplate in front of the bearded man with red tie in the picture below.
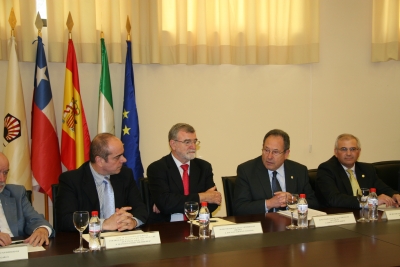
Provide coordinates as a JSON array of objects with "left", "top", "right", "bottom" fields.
[{"left": 213, "top": 222, "right": 263, "bottom": 238}]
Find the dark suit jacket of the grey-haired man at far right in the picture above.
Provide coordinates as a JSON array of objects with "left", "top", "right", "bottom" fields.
[{"left": 315, "top": 156, "right": 398, "bottom": 208}]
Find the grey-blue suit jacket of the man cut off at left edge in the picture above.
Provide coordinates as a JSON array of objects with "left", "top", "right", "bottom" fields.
[{"left": 0, "top": 184, "right": 54, "bottom": 237}]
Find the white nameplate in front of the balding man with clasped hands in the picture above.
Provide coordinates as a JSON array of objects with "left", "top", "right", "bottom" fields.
[{"left": 104, "top": 232, "right": 161, "bottom": 249}]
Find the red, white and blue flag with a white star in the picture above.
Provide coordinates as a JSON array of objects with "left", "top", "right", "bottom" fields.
[{"left": 31, "top": 36, "right": 61, "bottom": 199}]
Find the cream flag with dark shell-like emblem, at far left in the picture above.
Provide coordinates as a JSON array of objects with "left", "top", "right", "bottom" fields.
[{"left": 3, "top": 36, "right": 32, "bottom": 190}]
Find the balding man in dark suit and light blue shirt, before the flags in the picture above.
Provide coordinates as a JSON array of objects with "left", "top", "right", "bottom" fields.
[{"left": 56, "top": 133, "right": 147, "bottom": 231}]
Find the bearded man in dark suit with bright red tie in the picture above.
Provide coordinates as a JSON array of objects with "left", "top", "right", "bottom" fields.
[{"left": 147, "top": 123, "right": 221, "bottom": 223}]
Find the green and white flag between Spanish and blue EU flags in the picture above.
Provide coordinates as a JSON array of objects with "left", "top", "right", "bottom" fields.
[{"left": 97, "top": 38, "right": 115, "bottom": 134}]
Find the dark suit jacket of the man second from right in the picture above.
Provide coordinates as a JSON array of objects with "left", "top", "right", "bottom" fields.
[{"left": 234, "top": 156, "right": 318, "bottom": 215}]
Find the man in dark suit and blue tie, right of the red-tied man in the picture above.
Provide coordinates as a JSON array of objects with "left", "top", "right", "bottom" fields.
[{"left": 234, "top": 129, "right": 318, "bottom": 215}]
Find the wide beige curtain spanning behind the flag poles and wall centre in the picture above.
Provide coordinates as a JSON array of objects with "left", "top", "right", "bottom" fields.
[{"left": 47, "top": 0, "right": 319, "bottom": 65}]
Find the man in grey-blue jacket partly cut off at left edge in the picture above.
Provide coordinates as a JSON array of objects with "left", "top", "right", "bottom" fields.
[{"left": 0, "top": 152, "right": 54, "bottom": 246}]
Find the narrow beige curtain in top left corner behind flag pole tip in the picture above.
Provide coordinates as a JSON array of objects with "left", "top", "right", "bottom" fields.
[{"left": 0, "top": 0, "right": 37, "bottom": 61}]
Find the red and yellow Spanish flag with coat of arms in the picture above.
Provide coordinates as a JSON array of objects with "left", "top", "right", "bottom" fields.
[{"left": 61, "top": 39, "right": 90, "bottom": 170}]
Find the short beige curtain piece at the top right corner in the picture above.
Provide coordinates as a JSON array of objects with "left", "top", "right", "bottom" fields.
[{"left": 371, "top": 0, "right": 400, "bottom": 62}]
